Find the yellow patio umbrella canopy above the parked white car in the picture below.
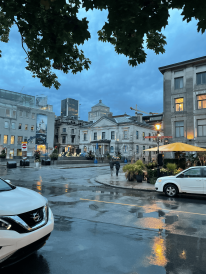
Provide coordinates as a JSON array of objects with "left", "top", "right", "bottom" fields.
[{"left": 144, "top": 143, "right": 206, "bottom": 152}]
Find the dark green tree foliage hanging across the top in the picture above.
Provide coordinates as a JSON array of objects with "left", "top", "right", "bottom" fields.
[{"left": 0, "top": 0, "right": 206, "bottom": 89}]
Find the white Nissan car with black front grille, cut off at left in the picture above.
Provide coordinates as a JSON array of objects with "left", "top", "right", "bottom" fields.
[{"left": 0, "top": 179, "right": 54, "bottom": 268}]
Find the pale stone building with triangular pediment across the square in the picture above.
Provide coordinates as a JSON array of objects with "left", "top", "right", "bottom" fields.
[{"left": 79, "top": 114, "right": 159, "bottom": 162}]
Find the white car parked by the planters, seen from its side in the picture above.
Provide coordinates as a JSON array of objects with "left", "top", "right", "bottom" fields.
[{"left": 155, "top": 166, "right": 206, "bottom": 197}]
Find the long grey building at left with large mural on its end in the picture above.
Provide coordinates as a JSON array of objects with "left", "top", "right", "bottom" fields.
[{"left": 0, "top": 89, "right": 55, "bottom": 158}]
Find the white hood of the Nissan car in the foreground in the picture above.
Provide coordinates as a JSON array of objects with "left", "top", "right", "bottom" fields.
[{"left": 0, "top": 187, "right": 46, "bottom": 216}]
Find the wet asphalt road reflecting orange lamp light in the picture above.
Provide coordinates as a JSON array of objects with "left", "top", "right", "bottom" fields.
[{"left": 0, "top": 167, "right": 206, "bottom": 274}]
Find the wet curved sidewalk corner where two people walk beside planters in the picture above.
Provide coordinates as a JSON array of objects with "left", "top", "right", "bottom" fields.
[{"left": 95, "top": 172, "right": 156, "bottom": 191}]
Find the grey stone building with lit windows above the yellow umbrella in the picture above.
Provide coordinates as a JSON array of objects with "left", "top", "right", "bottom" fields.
[{"left": 159, "top": 56, "right": 206, "bottom": 148}]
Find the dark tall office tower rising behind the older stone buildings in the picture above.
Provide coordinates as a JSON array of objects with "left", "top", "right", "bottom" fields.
[{"left": 61, "top": 98, "right": 79, "bottom": 120}]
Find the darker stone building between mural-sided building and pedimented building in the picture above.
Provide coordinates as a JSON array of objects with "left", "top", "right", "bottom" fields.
[{"left": 54, "top": 116, "right": 91, "bottom": 155}]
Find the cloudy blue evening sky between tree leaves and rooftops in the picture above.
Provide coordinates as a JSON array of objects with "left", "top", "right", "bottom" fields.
[{"left": 0, "top": 7, "right": 206, "bottom": 120}]
